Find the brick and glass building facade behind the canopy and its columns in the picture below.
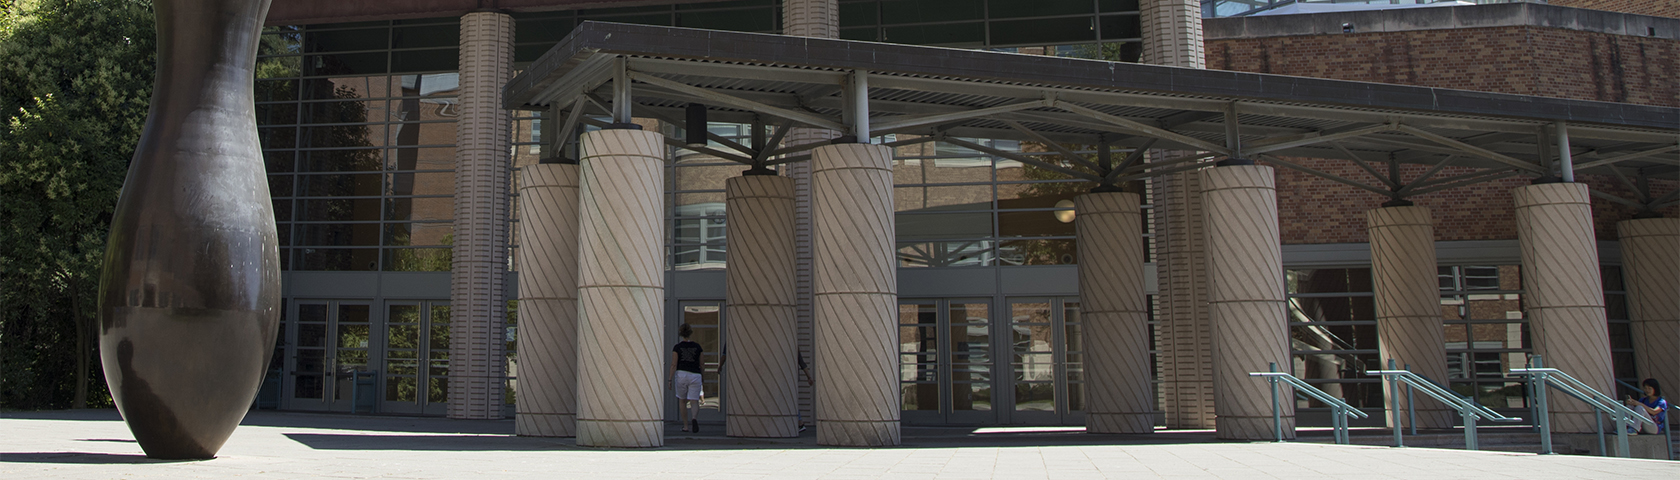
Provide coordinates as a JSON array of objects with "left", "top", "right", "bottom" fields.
[{"left": 255, "top": 0, "right": 1680, "bottom": 439}]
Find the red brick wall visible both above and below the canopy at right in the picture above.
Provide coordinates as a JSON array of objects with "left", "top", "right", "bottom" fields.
[{"left": 1206, "top": 27, "right": 1680, "bottom": 243}]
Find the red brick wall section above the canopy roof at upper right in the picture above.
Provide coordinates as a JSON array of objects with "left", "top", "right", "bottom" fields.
[{"left": 1206, "top": 27, "right": 1680, "bottom": 107}]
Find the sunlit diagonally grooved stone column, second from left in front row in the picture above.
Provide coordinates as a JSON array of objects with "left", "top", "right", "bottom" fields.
[{"left": 811, "top": 143, "right": 902, "bottom": 446}]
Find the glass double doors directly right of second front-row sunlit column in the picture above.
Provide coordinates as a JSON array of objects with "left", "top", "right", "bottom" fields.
[{"left": 899, "top": 299, "right": 998, "bottom": 425}]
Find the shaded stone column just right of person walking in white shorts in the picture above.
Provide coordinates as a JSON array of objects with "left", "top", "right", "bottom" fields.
[{"left": 724, "top": 175, "right": 800, "bottom": 436}]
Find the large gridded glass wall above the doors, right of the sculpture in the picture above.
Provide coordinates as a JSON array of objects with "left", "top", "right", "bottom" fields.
[{"left": 255, "top": 20, "right": 457, "bottom": 272}]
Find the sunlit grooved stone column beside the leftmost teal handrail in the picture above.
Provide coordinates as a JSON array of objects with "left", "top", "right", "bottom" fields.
[{"left": 1201, "top": 164, "right": 1295, "bottom": 440}]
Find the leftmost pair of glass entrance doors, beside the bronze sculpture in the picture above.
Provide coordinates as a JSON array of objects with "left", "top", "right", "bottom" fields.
[{"left": 282, "top": 300, "right": 378, "bottom": 411}]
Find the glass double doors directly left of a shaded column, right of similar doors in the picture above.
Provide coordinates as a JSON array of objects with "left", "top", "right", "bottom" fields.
[{"left": 1010, "top": 299, "right": 1085, "bottom": 425}]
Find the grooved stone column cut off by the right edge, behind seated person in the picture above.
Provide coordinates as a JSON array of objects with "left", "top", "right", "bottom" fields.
[{"left": 1616, "top": 218, "right": 1680, "bottom": 397}]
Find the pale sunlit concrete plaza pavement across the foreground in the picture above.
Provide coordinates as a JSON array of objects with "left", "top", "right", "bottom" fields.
[{"left": 0, "top": 410, "right": 1680, "bottom": 478}]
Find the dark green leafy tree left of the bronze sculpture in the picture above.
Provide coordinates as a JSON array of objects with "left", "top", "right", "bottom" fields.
[{"left": 0, "top": 0, "right": 156, "bottom": 408}]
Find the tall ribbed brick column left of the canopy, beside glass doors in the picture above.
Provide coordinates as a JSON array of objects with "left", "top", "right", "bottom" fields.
[{"left": 449, "top": 12, "right": 514, "bottom": 420}]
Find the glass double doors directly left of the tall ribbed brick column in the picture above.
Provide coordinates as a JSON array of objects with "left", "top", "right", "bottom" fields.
[{"left": 380, "top": 302, "right": 449, "bottom": 415}]
